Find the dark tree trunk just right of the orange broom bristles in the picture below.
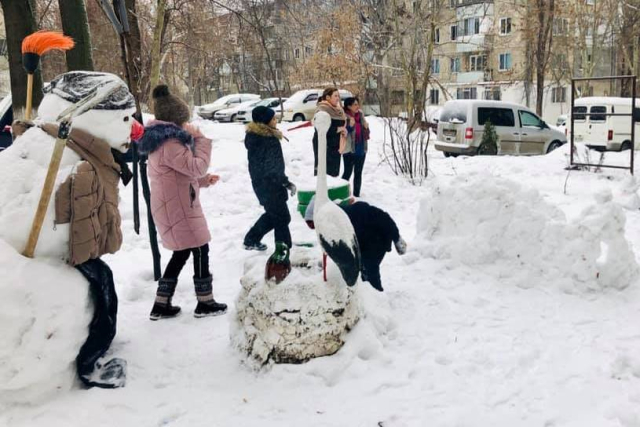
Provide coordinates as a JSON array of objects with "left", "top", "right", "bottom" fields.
[{"left": 58, "top": 0, "right": 93, "bottom": 71}]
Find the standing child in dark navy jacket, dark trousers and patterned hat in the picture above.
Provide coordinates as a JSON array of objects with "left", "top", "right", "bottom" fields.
[{"left": 244, "top": 107, "right": 296, "bottom": 251}]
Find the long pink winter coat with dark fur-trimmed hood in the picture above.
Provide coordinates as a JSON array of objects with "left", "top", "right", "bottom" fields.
[{"left": 140, "top": 121, "right": 211, "bottom": 251}]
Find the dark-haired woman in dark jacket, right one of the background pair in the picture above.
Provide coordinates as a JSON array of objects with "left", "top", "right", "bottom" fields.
[{"left": 342, "top": 98, "right": 369, "bottom": 197}]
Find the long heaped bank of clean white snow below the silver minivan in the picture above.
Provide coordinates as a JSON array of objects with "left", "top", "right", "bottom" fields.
[{"left": 418, "top": 175, "right": 638, "bottom": 292}]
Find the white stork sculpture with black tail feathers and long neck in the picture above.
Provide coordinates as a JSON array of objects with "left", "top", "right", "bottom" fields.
[{"left": 313, "top": 112, "right": 360, "bottom": 286}]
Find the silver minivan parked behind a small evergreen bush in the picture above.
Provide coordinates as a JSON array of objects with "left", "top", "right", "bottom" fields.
[{"left": 435, "top": 100, "right": 567, "bottom": 157}]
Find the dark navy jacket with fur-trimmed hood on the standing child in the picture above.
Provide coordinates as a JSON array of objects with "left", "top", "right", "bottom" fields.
[{"left": 244, "top": 122, "right": 289, "bottom": 206}]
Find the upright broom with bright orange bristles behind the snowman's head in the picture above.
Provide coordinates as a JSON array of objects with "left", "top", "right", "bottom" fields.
[{"left": 22, "top": 31, "right": 74, "bottom": 120}]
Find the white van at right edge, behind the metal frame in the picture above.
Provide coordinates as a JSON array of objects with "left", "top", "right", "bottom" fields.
[{"left": 567, "top": 96, "right": 640, "bottom": 151}]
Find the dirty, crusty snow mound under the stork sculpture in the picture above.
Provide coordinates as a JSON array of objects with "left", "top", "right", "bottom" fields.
[{"left": 231, "top": 250, "right": 360, "bottom": 366}]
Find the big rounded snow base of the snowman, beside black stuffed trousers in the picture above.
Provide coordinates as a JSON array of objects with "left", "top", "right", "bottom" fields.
[{"left": 0, "top": 241, "right": 92, "bottom": 412}]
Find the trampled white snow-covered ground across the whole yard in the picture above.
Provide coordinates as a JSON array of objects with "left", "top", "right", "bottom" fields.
[{"left": 0, "top": 121, "right": 640, "bottom": 427}]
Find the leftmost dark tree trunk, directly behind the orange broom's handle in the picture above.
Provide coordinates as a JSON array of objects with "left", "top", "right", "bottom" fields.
[{"left": 0, "top": 0, "right": 42, "bottom": 119}]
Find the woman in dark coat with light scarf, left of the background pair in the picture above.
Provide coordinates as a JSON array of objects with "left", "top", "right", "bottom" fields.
[{"left": 313, "top": 88, "right": 347, "bottom": 177}]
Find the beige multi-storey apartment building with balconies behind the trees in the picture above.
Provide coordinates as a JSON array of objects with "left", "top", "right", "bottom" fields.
[{"left": 420, "top": 0, "right": 615, "bottom": 124}]
